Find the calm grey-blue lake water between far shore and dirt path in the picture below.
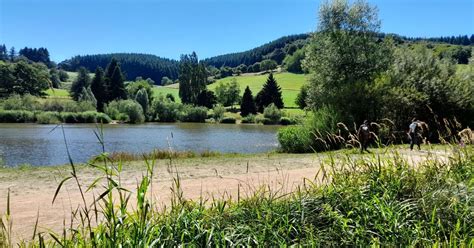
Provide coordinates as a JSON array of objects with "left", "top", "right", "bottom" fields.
[{"left": 0, "top": 123, "right": 278, "bottom": 166}]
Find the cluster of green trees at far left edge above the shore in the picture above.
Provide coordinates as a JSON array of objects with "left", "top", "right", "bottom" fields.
[{"left": 0, "top": 60, "right": 51, "bottom": 96}]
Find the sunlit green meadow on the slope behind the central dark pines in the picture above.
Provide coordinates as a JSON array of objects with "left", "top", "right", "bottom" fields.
[{"left": 153, "top": 72, "right": 308, "bottom": 108}]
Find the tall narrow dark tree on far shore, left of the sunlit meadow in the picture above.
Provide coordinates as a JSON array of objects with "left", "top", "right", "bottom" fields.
[{"left": 179, "top": 52, "right": 207, "bottom": 104}]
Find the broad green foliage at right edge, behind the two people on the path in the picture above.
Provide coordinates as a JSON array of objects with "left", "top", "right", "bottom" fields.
[{"left": 373, "top": 47, "right": 474, "bottom": 137}]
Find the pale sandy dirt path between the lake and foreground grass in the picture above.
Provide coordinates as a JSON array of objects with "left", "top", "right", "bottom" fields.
[{"left": 0, "top": 147, "right": 447, "bottom": 240}]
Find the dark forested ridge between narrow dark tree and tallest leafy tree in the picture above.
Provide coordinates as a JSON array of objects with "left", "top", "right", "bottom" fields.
[{"left": 204, "top": 34, "right": 310, "bottom": 68}]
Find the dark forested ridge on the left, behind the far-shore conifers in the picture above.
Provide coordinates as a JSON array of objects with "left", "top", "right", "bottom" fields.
[{"left": 59, "top": 53, "right": 179, "bottom": 84}]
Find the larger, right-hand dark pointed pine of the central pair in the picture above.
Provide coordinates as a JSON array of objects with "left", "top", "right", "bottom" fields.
[{"left": 256, "top": 73, "right": 284, "bottom": 112}]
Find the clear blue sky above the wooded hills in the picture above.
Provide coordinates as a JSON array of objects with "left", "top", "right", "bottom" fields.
[{"left": 0, "top": 0, "right": 474, "bottom": 62}]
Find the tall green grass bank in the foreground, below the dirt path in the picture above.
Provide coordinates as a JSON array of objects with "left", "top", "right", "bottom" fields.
[{"left": 0, "top": 147, "right": 474, "bottom": 247}]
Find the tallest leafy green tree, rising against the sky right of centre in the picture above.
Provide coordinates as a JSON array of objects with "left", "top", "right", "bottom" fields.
[{"left": 304, "top": 0, "right": 392, "bottom": 122}]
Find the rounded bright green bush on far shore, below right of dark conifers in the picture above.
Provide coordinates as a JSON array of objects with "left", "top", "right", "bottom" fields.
[{"left": 105, "top": 100, "right": 145, "bottom": 123}]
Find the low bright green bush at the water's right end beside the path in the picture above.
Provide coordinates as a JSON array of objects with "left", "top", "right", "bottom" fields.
[{"left": 277, "top": 126, "right": 313, "bottom": 153}]
